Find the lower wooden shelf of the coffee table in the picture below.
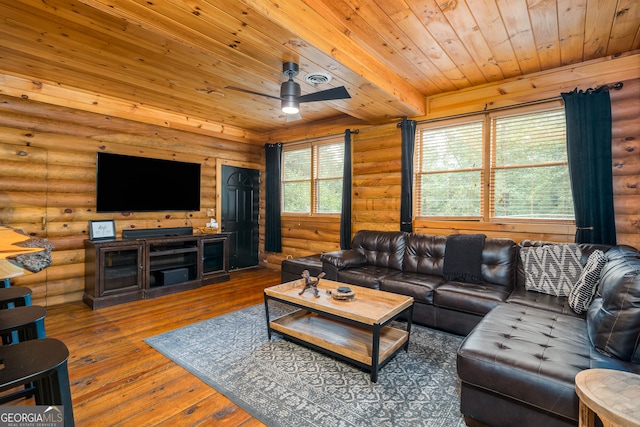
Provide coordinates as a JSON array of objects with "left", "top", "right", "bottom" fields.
[{"left": 269, "top": 309, "right": 409, "bottom": 381}]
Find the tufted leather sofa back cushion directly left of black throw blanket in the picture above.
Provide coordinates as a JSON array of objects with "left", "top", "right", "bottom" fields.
[{"left": 402, "top": 233, "right": 447, "bottom": 276}]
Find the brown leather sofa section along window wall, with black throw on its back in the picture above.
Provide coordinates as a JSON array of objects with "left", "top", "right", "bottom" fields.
[{"left": 320, "top": 231, "right": 516, "bottom": 335}]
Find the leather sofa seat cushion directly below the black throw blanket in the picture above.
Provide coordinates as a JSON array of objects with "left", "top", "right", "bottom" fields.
[{"left": 433, "top": 282, "right": 510, "bottom": 316}]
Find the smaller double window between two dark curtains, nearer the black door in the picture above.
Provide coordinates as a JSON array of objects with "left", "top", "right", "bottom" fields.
[{"left": 282, "top": 140, "right": 344, "bottom": 214}]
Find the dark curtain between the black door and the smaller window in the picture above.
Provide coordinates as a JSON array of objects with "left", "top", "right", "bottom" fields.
[{"left": 264, "top": 144, "right": 282, "bottom": 252}]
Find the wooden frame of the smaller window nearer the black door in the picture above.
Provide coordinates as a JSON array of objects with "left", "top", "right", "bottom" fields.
[{"left": 280, "top": 136, "right": 344, "bottom": 218}]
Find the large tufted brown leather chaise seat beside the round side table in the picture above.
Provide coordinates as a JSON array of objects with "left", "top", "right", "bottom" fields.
[{"left": 457, "top": 304, "right": 640, "bottom": 420}]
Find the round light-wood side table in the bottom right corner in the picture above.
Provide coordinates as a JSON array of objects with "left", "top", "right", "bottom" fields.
[{"left": 576, "top": 369, "right": 640, "bottom": 427}]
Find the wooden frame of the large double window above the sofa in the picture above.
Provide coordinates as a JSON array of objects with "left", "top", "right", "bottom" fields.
[{"left": 413, "top": 100, "right": 575, "bottom": 225}]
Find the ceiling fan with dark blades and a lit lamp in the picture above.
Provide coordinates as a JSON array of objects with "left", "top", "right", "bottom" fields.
[{"left": 226, "top": 62, "right": 351, "bottom": 122}]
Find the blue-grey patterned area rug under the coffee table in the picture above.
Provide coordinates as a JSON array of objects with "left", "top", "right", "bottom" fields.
[{"left": 145, "top": 304, "right": 465, "bottom": 427}]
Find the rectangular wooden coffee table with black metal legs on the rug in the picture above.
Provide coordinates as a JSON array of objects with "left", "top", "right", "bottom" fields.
[{"left": 264, "top": 279, "right": 413, "bottom": 382}]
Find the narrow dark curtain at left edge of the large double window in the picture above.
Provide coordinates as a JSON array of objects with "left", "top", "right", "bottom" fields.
[{"left": 398, "top": 119, "right": 416, "bottom": 233}]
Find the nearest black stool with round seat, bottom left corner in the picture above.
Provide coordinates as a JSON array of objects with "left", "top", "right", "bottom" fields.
[{"left": 0, "top": 338, "right": 75, "bottom": 427}]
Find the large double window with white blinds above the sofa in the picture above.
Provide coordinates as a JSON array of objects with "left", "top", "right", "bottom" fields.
[{"left": 414, "top": 107, "right": 574, "bottom": 221}]
